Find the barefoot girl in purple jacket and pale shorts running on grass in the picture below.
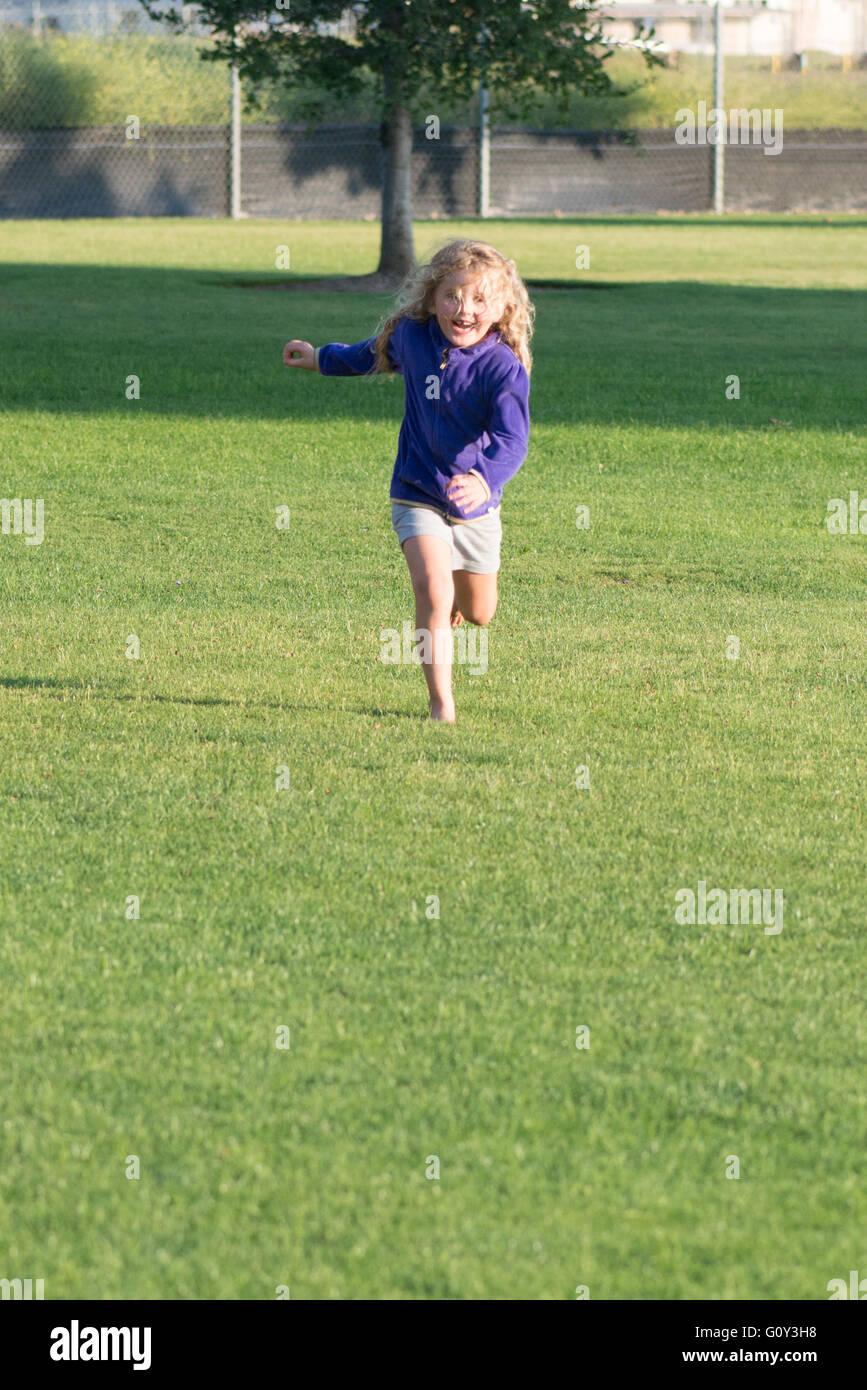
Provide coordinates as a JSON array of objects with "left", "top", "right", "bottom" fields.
[{"left": 283, "top": 240, "right": 534, "bottom": 724}]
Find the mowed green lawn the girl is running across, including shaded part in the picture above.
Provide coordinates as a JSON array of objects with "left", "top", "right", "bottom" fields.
[{"left": 0, "top": 218, "right": 867, "bottom": 1300}]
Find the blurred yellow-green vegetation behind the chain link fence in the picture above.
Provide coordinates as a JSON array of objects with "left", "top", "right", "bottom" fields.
[{"left": 0, "top": 31, "right": 867, "bottom": 129}]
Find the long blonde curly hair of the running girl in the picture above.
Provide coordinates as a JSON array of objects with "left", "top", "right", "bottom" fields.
[{"left": 374, "top": 238, "right": 535, "bottom": 375}]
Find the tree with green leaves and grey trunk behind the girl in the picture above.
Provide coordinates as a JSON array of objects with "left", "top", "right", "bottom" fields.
[{"left": 140, "top": 0, "right": 659, "bottom": 278}]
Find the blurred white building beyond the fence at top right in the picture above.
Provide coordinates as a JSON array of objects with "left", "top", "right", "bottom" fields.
[{"left": 602, "top": 0, "right": 867, "bottom": 58}]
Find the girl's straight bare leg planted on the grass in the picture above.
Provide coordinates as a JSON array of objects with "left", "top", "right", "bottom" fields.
[{"left": 403, "top": 535, "right": 454, "bottom": 724}]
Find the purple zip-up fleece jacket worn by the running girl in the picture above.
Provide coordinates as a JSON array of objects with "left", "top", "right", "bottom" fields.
[{"left": 318, "top": 316, "right": 529, "bottom": 521}]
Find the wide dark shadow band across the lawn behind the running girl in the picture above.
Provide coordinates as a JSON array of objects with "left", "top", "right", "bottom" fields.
[{"left": 0, "top": 262, "right": 867, "bottom": 430}]
